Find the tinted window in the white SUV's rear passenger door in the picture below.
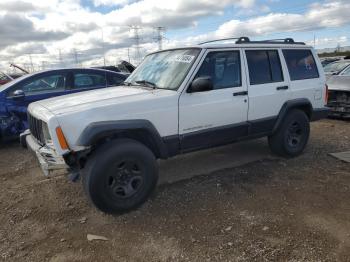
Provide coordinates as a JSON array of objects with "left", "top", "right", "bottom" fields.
[{"left": 246, "top": 50, "right": 283, "bottom": 85}]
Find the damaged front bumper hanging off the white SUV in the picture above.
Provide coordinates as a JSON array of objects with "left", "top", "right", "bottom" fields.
[{"left": 20, "top": 130, "right": 69, "bottom": 176}]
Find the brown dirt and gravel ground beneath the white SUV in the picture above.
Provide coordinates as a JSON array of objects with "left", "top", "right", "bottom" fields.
[{"left": 0, "top": 120, "right": 350, "bottom": 261}]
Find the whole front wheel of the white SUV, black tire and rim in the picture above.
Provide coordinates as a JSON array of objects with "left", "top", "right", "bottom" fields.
[{"left": 82, "top": 139, "right": 158, "bottom": 214}]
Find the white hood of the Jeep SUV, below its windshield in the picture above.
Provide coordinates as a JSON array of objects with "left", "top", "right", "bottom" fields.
[{"left": 33, "top": 86, "right": 174, "bottom": 115}]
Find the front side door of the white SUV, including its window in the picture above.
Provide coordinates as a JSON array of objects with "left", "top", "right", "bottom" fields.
[{"left": 179, "top": 49, "right": 248, "bottom": 152}]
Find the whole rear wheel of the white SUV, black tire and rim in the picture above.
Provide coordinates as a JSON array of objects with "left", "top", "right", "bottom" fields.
[{"left": 268, "top": 109, "right": 310, "bottom": 157}]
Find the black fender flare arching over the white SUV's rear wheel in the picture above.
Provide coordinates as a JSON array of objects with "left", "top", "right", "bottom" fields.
[{"left": 272, "top": 98, "right": 313, "bottom": 133}]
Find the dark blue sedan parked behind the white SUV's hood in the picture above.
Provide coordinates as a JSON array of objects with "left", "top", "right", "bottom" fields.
[{"left": 0, "top": 68, "right": 128, "bottom": 141}]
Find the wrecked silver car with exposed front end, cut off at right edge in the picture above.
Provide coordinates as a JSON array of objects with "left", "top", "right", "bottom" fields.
[{"left": 327, "top": 66, "right": 350, "bottom": 119}]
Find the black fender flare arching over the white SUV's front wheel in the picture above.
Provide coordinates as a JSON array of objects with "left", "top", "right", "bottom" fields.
[{"left": 77, "top": 119, "right": 168, "bottom": 159}]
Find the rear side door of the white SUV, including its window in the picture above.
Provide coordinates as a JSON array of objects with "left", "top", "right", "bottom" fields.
[{"left": 244, "top": 48, "right": 290, "bottom": 134}]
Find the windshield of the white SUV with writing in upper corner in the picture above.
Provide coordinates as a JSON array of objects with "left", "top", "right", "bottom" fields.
[{"left": 125, "top": 48, "right": 200, "bottom": 90}]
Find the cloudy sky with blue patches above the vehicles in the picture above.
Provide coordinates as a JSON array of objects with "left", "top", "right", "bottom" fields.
[{"left": 0, "top": 0, "right": 350, "bottom": 70}]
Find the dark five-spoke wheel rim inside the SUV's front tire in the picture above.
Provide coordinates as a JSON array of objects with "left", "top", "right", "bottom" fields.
[{"left": 107, "top": 160, "right": 143, "bottom": 198}]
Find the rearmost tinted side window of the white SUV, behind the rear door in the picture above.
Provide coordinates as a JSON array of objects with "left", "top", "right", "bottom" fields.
[{"left": 283, "top": 49, "right": 319, "bottom": 81}]
